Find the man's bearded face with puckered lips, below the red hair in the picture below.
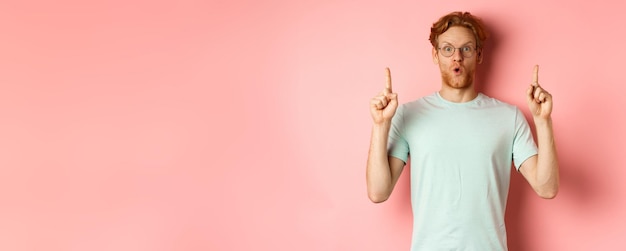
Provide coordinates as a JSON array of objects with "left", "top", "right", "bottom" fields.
[{"left": 432, "top": 26, "right": 482, "bottom": 89}]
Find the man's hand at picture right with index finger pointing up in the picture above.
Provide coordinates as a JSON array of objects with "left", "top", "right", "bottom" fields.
[{"left": 526, "top": 65, "right": 552, "bottom": 120}]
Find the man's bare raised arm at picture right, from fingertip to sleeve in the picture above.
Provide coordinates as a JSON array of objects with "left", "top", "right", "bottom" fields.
[{"left": 520, "top": 66, "right": 559, "bottom": 199}]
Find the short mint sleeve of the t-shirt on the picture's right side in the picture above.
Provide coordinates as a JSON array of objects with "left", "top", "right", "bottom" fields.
[{"left": 513, "top": 108, "right": 537, "bottom": 171}]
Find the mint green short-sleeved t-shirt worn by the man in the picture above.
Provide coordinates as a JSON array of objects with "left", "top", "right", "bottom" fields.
[{"left": 388, "top": 92, "right": 537, "bottom": 251}]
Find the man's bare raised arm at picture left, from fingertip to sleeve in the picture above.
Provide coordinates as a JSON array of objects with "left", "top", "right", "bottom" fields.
[{"left": 366, "top": 68, "right": 405, "bottom": 203}]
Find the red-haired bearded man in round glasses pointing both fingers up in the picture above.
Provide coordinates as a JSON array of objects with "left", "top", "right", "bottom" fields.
[{"left": 366, "top": 12, "right": 559, "bottom": 251}]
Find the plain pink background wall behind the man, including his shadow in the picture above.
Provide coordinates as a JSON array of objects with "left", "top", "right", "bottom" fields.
[{"left": 0, "top": 0, "right": 626, "bottom": 251}]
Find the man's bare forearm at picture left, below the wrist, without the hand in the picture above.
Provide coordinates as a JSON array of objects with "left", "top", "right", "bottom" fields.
[{"left": 366, "top": 123, "right": 393, "bottom": 202}]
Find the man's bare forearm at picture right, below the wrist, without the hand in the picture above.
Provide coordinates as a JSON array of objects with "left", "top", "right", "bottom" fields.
[{"left": 535, "top": 118, "right": 559, "bottom": 198}]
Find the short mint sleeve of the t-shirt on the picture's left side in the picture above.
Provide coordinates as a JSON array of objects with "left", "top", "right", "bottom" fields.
[{"left": 387, "top": 106, "right": 409, "bottom": 163}]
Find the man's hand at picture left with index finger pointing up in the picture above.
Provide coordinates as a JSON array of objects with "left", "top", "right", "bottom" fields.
[{"left": 370, "top": 67, "right": 398, "bottom": 125}]
